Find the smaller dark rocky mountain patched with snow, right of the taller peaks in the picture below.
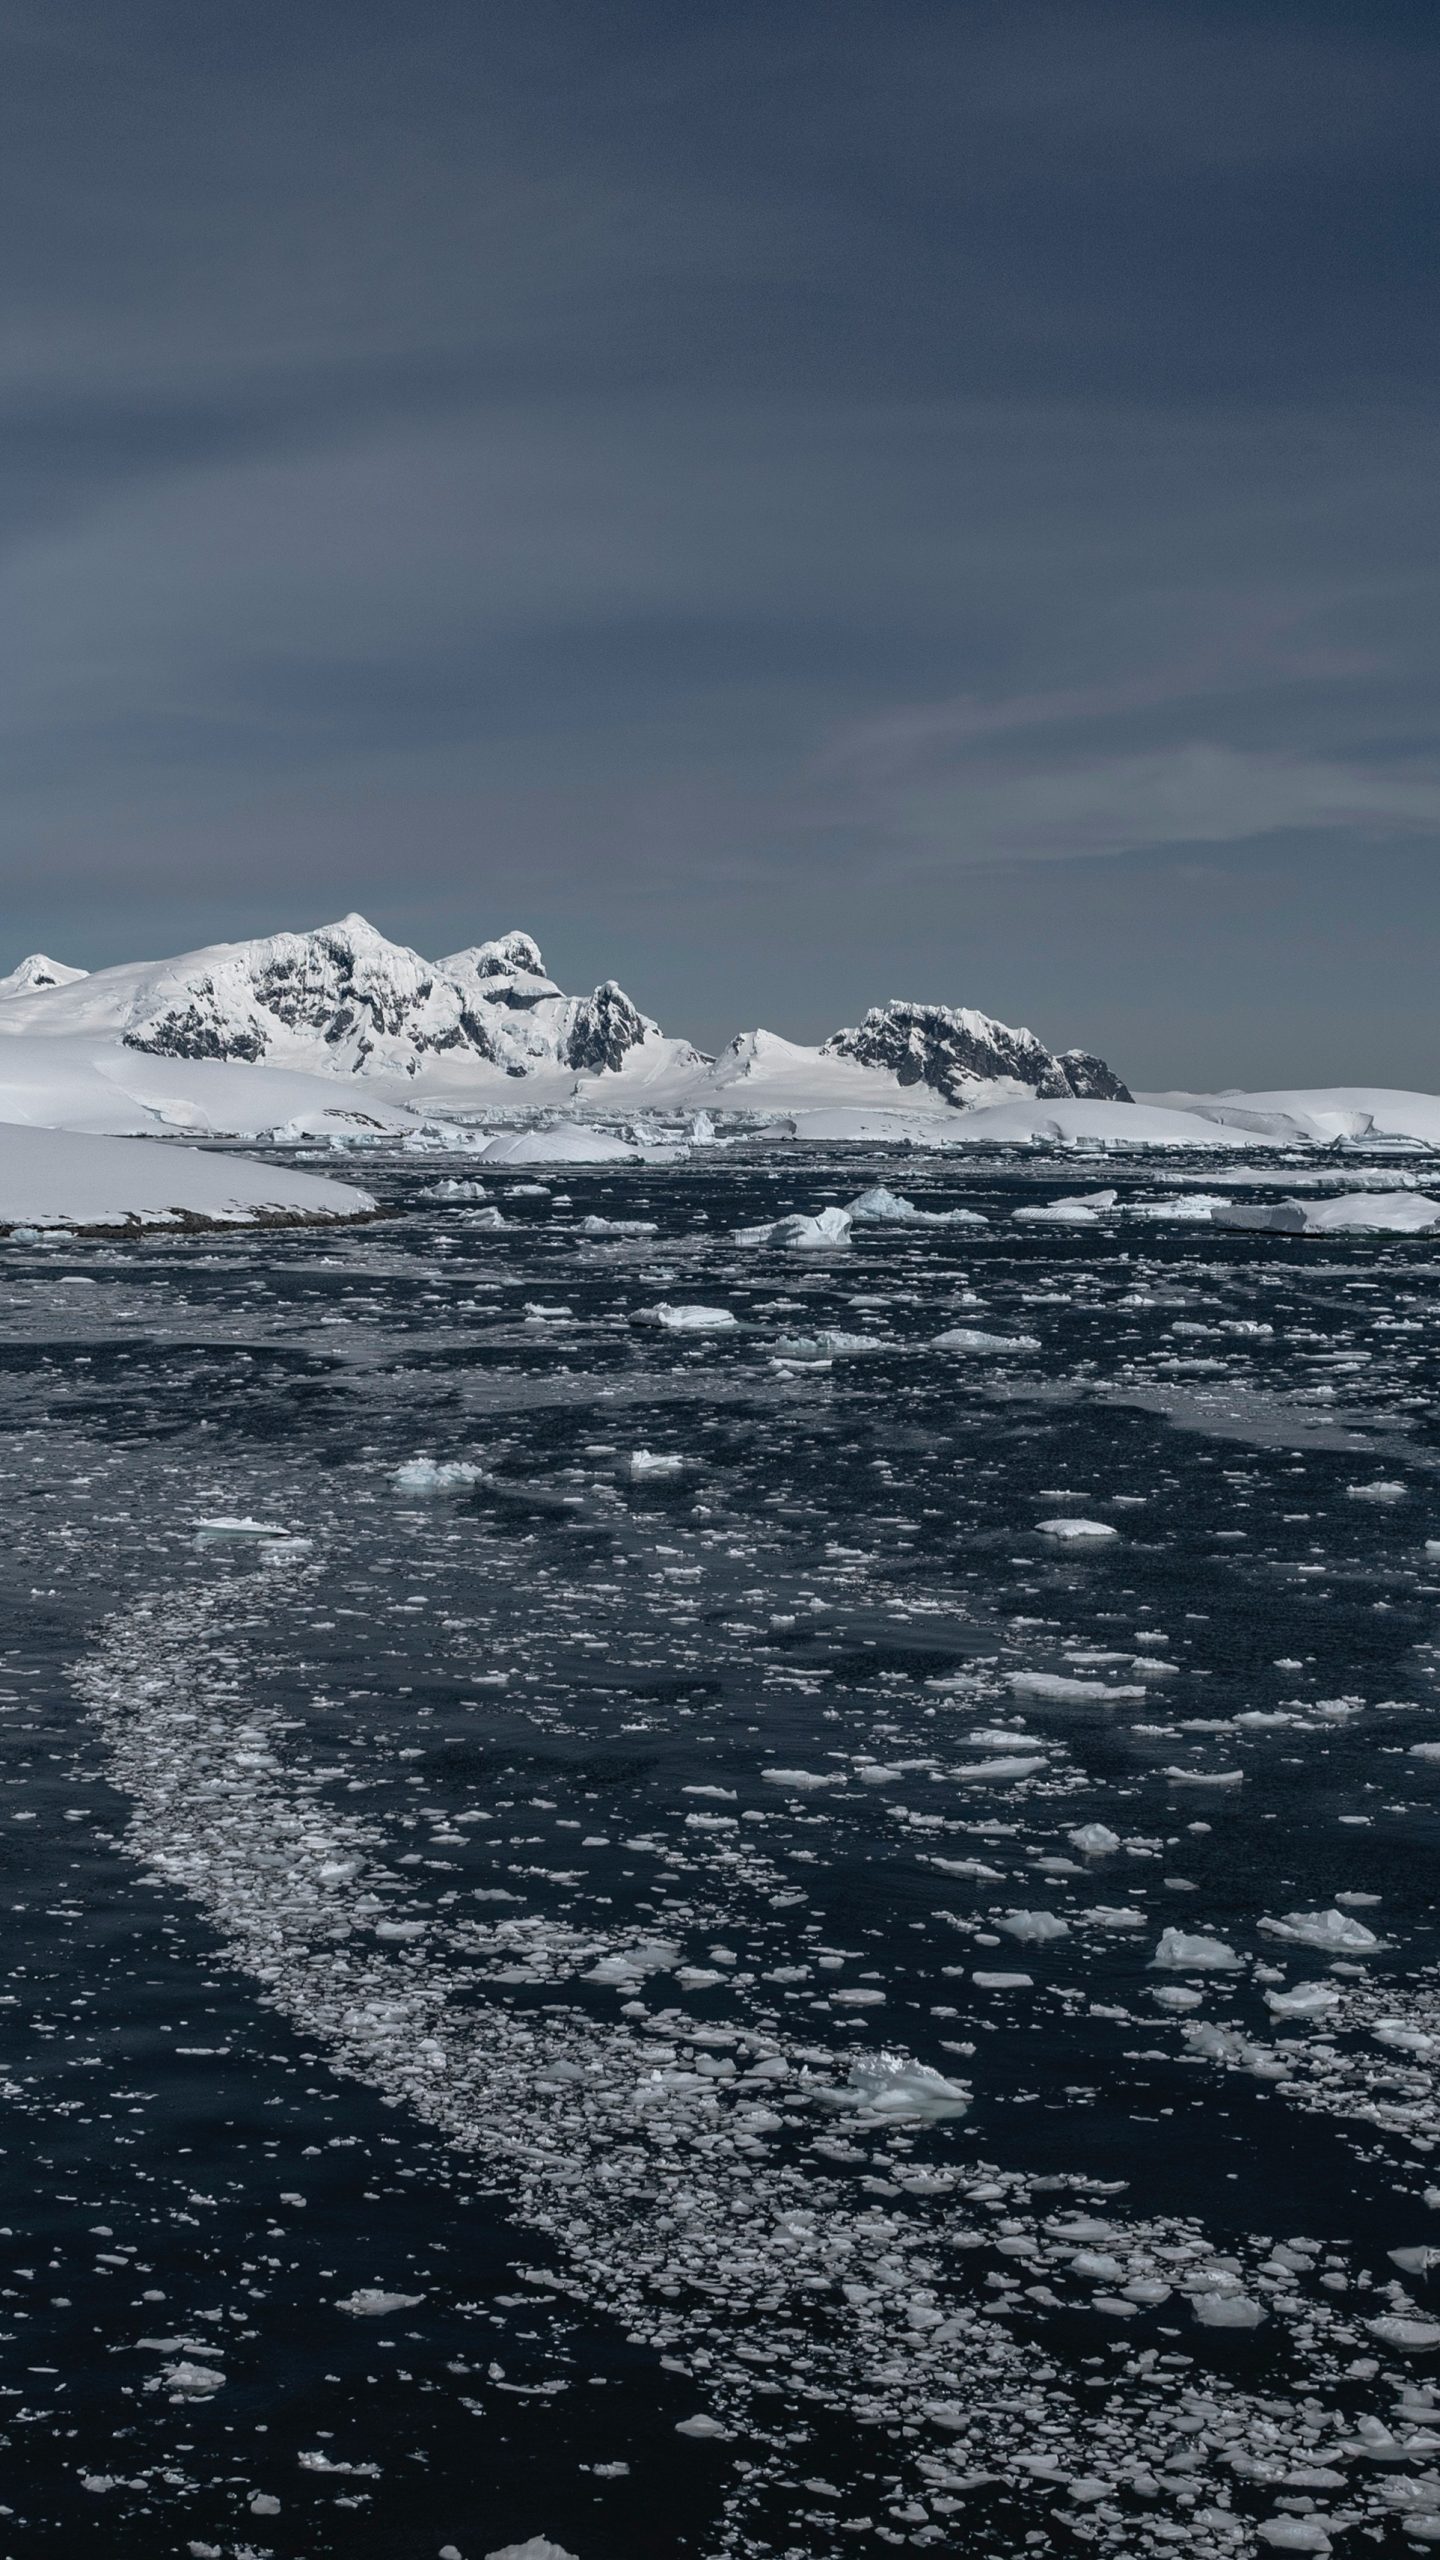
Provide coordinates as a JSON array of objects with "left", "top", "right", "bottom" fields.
[{"left": 820, "top": 998, "right": 1130, "bottom": 1106}]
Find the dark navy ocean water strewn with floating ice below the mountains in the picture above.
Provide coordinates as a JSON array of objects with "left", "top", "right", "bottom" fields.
[{"left": 0, "top": 1149, "right": 1440, "bottom": 2560}]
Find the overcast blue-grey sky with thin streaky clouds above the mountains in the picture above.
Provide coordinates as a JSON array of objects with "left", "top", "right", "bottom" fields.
[{"left": 0, "top": 0, "right": 1440, "bottom": 1088}]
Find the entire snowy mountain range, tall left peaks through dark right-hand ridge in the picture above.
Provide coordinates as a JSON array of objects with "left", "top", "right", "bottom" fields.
[{"left": 0, "top": 916, "right": 1130, "bottom": 1114}]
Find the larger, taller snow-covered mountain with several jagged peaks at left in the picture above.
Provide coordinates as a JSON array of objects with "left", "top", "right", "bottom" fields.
[{"left": 0, "top": 916, "right": 702, "bottom": 1078}]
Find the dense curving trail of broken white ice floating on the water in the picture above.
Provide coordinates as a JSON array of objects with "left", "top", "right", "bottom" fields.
[{"left": 79, "top": 1567, "right": 1440, "bottom": 2560}]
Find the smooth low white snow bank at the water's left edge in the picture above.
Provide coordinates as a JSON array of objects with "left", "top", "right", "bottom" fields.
[{"left": 0, "top": 1124, "right": 374, "bottom": 1226}]
